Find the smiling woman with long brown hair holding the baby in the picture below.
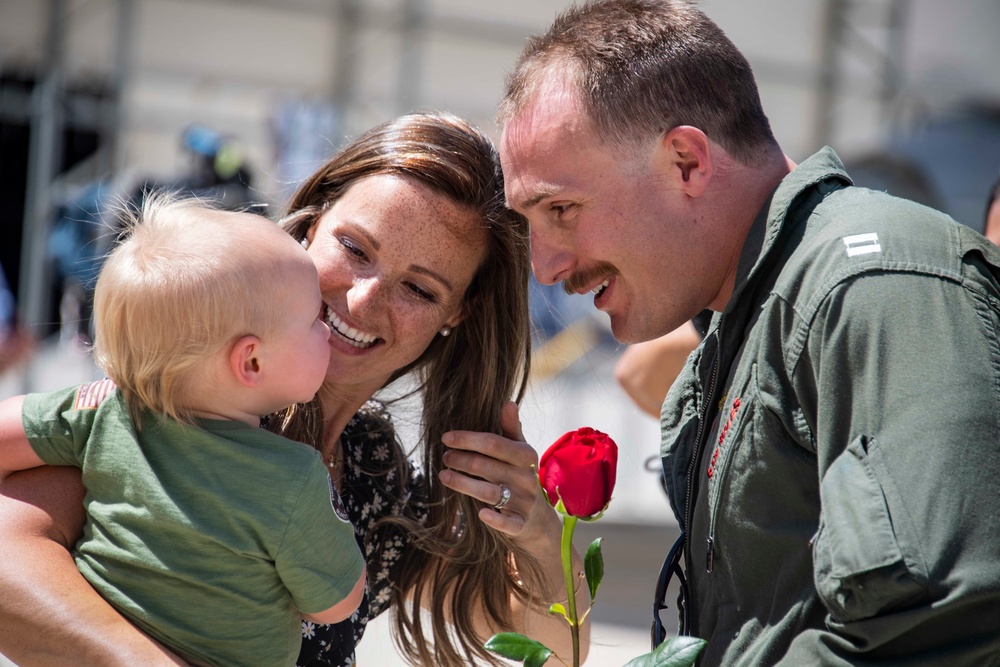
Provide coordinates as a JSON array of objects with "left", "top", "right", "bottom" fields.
[{"left": 0, "top": 114, "right": 589, "bottom": 667}]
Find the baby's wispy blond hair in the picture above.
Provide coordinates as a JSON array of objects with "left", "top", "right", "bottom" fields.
[{"left": 94, "top": 192, "right": 281, "bottom": 427}]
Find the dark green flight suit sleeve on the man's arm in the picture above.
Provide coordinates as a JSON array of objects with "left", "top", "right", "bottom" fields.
[{"left": 780, "top": 272, "right": 1000, "bottom": 665}]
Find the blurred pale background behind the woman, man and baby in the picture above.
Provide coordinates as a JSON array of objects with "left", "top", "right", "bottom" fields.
[{"left": 0, "top": 0, "right": 1000, "bottom": 664}]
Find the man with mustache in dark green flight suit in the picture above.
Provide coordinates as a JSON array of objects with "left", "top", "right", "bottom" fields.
[{"left": 499, "top": 0, "right": 1000, "bottom": 667}]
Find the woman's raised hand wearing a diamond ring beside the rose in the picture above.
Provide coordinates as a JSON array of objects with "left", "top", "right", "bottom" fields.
[{"left": 440, "top": 403, "right": 560, "bottom": 551}]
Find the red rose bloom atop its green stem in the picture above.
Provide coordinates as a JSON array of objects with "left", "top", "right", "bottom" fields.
[{"left": 538, "top": 427, "right": 618, "bottom": 518}]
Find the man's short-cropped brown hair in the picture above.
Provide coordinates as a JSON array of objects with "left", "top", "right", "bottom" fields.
[{"left": 499, "top": 0, "right": 777, "bottom": 165}]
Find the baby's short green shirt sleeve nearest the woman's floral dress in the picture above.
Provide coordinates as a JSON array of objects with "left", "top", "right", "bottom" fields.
[{"left": 275, "top": 457, "right": 364, "bottom": 614}]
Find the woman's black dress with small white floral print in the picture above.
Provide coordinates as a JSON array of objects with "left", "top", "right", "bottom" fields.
[{"left": 296, "top": 401, "right": 427, "bottom": 667}]
